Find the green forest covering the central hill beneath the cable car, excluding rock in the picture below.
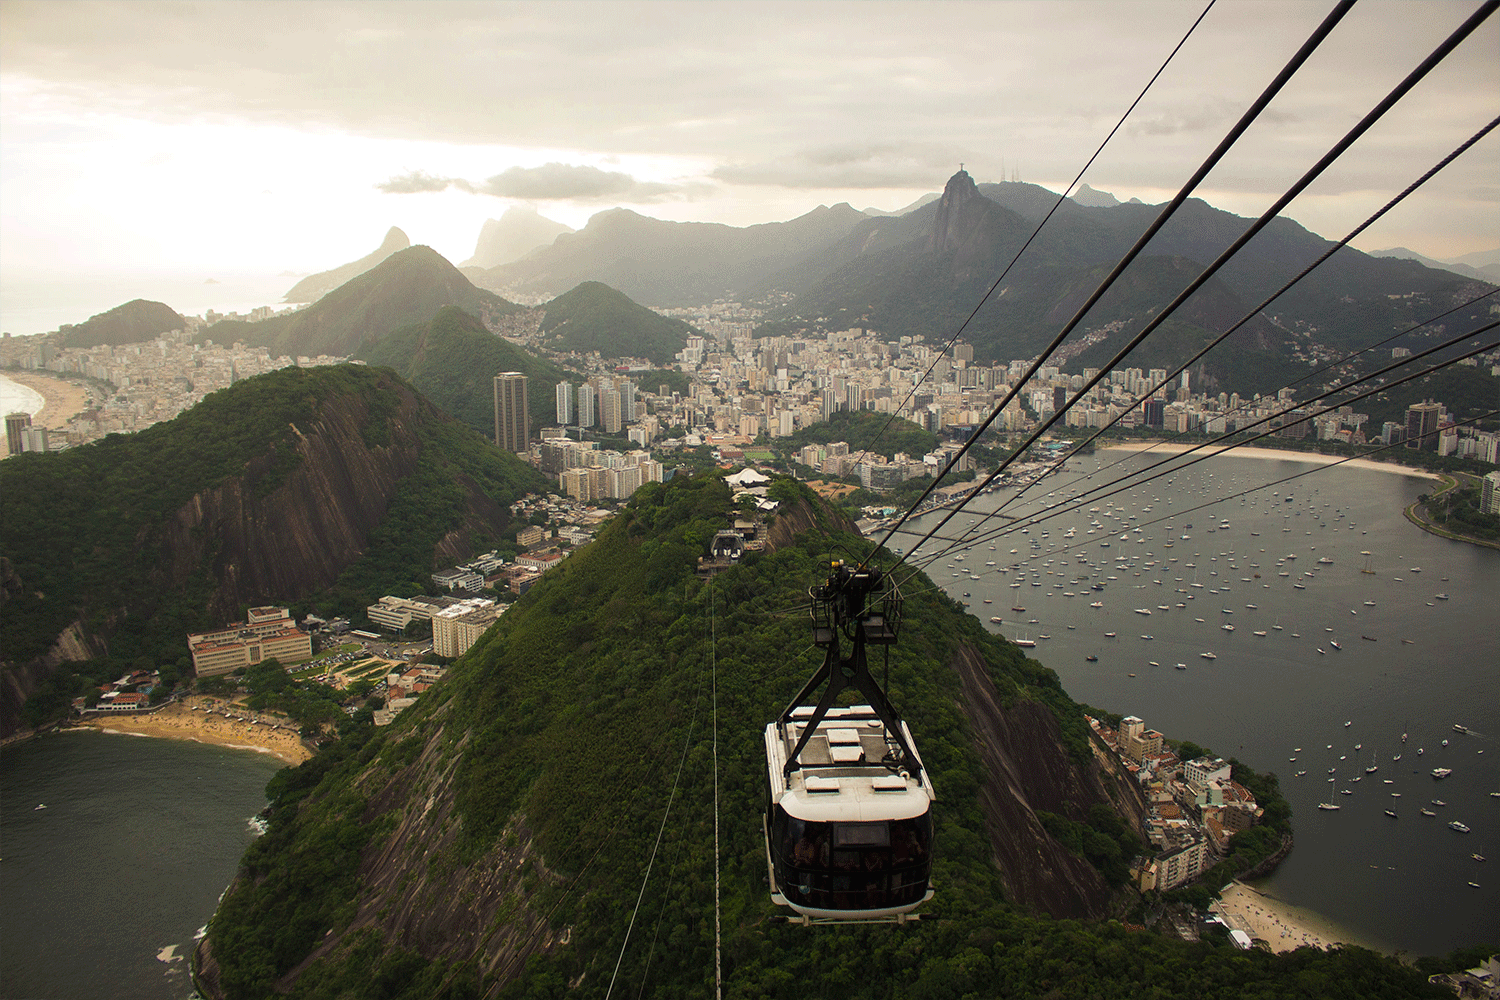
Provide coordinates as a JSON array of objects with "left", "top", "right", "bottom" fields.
[{"left": 199, "top": 474, "right": 1440, "bottom": 1000}]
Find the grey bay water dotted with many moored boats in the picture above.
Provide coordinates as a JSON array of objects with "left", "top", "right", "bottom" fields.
[{"left": 893, "top": 451, "right": 1500, "bottom": 954}]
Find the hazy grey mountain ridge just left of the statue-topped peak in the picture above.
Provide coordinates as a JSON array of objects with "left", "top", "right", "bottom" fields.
[{"left": 474, "top": 204, "right": 867, "bottom": 307}]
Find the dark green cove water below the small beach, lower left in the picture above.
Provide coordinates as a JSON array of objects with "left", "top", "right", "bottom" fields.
[{"left": 0, "top": 730, "right": 281, "bottom": 1000}]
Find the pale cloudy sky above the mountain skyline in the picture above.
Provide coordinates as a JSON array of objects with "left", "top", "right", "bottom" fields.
[{"left": 0, "top": 0, "right": 1500, "bottom": 333}]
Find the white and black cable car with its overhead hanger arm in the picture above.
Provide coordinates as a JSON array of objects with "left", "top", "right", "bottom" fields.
[{"left": 764, "top": 562, "right": 936, "bottom": 925}]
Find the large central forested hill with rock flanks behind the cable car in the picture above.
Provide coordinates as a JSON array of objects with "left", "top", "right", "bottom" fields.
[{"left": 194, "top": 472, "right": 1425, "bottom": 1000}]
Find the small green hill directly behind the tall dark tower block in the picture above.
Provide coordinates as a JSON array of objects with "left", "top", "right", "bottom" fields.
[{"left": 359, "top": 306, "right": 573, "bottom": 438}]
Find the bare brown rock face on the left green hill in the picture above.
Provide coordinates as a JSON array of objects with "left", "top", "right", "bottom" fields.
[{"left": 0, "top": 373, "right": 528, "bottom": 736}]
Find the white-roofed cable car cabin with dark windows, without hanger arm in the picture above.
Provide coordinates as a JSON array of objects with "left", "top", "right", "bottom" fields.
[{"left": 765, "top": 705, "right": 936, "bottom": 924}]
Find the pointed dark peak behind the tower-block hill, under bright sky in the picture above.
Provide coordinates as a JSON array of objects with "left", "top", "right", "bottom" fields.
[{"left": 200, "top": 246, "right": 524, "bottom": 357}]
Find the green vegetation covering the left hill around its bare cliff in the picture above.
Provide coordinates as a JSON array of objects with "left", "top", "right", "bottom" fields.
[{"left": 0, "top": 366, "right": 545, "bottom": 677}]
